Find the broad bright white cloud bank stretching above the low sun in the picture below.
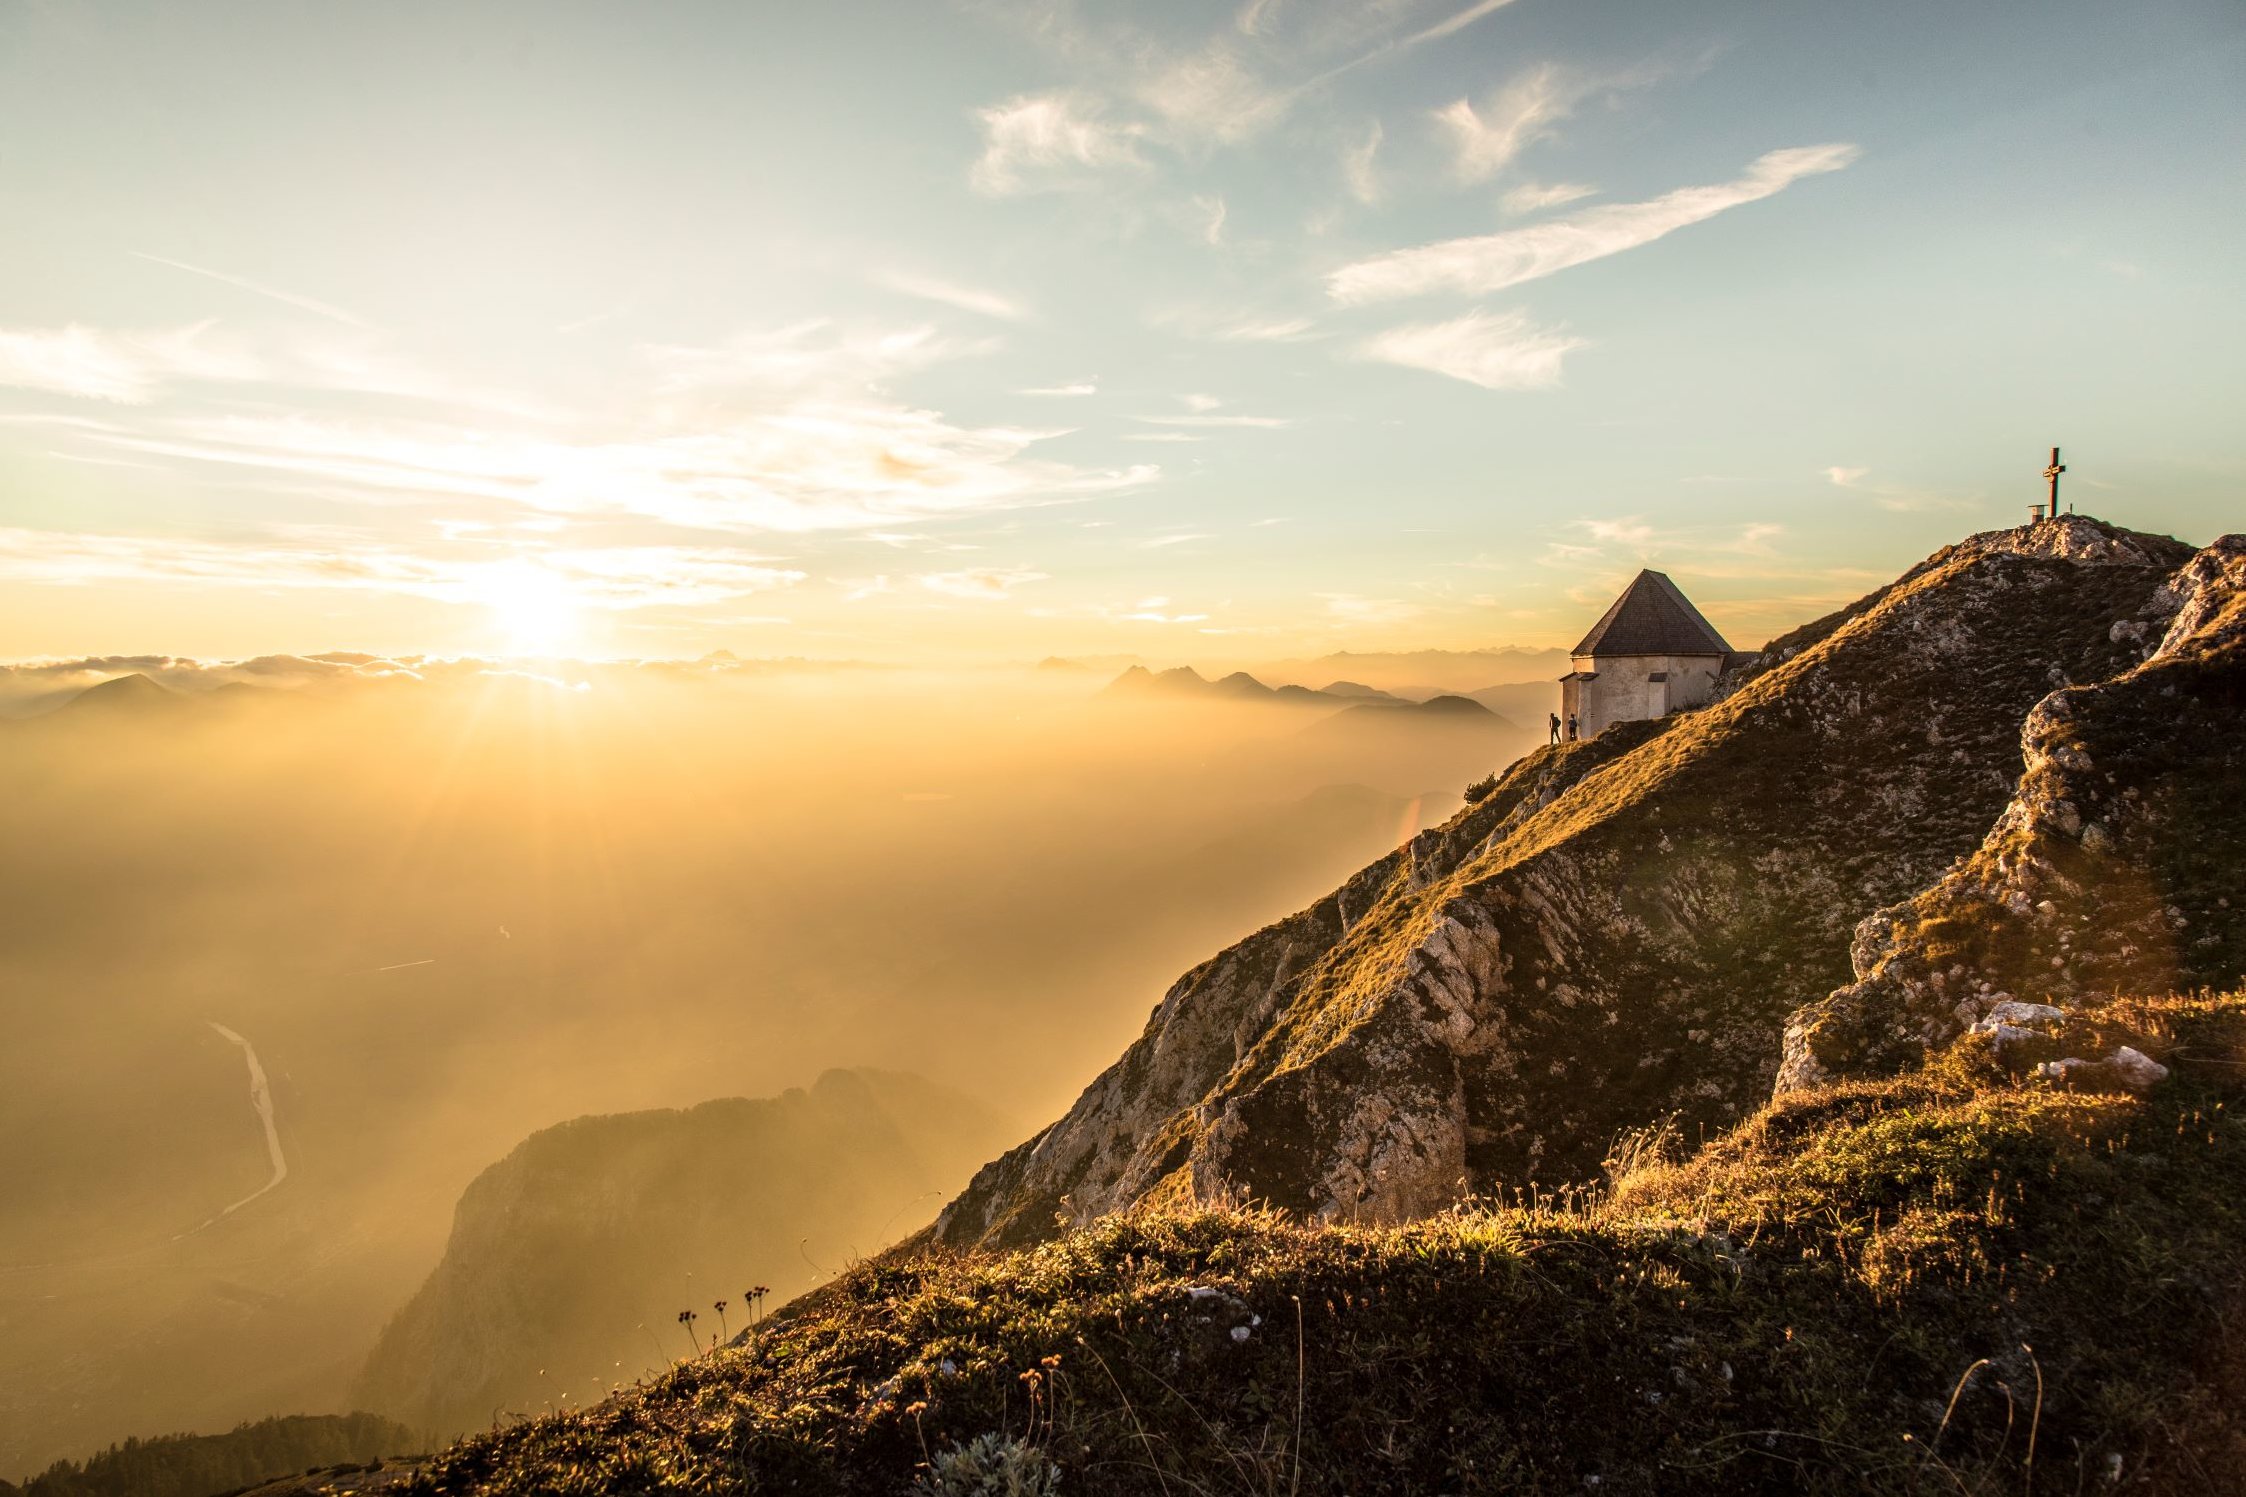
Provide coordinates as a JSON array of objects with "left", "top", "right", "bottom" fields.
[{"left": 39, "top": 323, "right": 1159, "bottom": 532}]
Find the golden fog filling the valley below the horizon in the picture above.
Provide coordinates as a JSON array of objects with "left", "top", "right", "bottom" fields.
[{"left": 0, "top": 655, "right": 1556, "bottom": 1477}]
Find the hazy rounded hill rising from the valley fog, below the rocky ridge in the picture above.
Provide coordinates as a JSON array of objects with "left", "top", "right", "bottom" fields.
[{"left": 357, "top": 1071, "right": 1002, "bottom": 1432}]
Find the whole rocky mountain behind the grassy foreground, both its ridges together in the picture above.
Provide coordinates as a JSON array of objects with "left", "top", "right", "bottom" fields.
[{"left": 932, "top": 516, "right": 2242, "bottom": 1246}]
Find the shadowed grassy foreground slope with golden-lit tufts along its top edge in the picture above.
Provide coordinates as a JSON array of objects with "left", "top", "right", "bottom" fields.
[{"left": 399, "top": 994, "right": 2246, "bottom": 1495}]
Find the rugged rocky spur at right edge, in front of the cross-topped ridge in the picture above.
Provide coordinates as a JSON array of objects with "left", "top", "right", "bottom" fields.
[{"left": 1779, "top": 536, "right": 2246, "bottom": 1089}]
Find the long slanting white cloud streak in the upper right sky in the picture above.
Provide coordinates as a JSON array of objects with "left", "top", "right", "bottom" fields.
[{"left": 1325, "top": 144, "right": 1857, "bottom": 305}]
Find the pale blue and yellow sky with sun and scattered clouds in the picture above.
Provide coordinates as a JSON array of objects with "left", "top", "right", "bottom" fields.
[{"left": 0, "top": 0, "right": 2246, "bottom": 662}]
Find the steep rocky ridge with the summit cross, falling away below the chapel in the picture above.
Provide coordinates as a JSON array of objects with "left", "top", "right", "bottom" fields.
[{"left": 934, "top": 516, "right": 2190, "bottom": 1246}]
